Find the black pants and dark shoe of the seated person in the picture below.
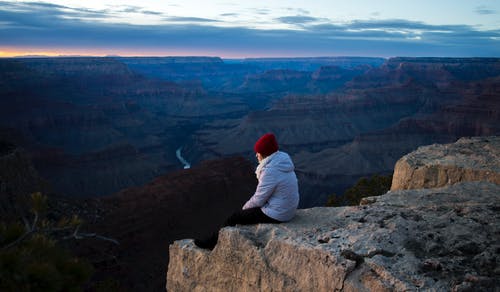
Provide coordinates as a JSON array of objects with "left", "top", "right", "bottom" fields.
[{"left": 194, "top": 207, "right": 281, "bottom": 249}]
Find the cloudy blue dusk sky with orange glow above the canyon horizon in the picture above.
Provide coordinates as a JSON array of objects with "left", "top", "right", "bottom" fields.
[{"left": 0, "top": 0, "right": 500, "bottom": 58}]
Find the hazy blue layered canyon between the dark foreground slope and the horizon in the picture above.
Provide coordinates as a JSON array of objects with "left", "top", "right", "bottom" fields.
[{"left": 0, "top": 57, "right": 500, "bottom": 203}]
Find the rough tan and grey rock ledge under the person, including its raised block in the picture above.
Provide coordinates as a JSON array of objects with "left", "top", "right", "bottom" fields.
[{"left": 167, "top": 137, "right": 500, "bottom": 291}]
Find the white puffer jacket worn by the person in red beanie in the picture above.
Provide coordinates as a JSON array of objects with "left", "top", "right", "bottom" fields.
[{"left": 243, "top": 151, "right": 299, "bottom": 222}]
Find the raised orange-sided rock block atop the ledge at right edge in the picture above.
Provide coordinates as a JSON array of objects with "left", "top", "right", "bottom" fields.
[{"left": 391, "top": 137, "right": 500, "bottom": 190}]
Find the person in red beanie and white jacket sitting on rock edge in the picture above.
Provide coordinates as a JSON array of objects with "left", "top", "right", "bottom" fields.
[{"left": 194, "top": 133, "right": 299, "bottom": 249}]
